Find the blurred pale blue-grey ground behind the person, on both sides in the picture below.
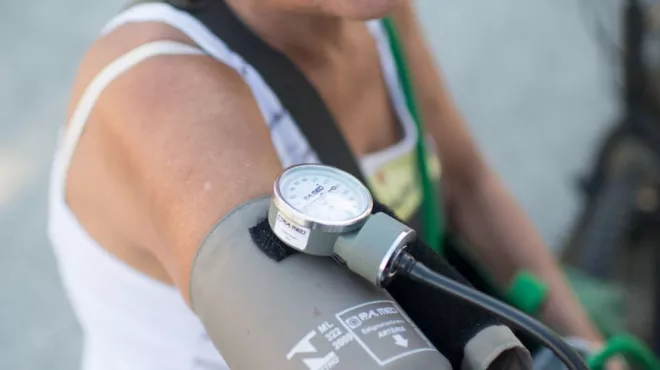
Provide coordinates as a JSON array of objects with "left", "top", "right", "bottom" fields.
[{"left": 0, "top": 0, "right": 617, "bottom": 370}]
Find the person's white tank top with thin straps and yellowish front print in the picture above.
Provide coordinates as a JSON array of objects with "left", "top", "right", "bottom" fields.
[{"left": 48, "top": 3, "right": 440, "bottom": 370}]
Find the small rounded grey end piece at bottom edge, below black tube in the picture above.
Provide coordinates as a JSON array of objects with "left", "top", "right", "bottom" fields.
[{"left": 461, "top": 326, "right": 532, "bottom": 370}]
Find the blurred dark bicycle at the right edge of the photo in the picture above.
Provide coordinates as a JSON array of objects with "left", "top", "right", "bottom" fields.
[{"left": 563, "top": 0, "right": 660, "bottom": 355}]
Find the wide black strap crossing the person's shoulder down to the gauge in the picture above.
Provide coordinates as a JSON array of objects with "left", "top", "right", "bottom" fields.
[{"left": 175, "top": 0, "right": 367, "bottom": 185}]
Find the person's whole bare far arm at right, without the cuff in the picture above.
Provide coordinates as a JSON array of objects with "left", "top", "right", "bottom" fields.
[{"left": 392, "top": 4, "right": 598, "bottom": 340}]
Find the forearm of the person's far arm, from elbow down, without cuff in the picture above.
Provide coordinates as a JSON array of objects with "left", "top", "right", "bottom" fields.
[{"left": 447, "top": 173, "right": 601, "bottom": 341}]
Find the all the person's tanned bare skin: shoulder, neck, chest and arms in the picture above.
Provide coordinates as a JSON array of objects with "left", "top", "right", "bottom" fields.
[{"left": 66, "top": 0, "right": 616, "bottom": 364}]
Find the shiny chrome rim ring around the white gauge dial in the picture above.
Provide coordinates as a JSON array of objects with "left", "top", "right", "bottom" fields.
[{"left": 273, "top": 163, "right": 373, "bottom": 233}]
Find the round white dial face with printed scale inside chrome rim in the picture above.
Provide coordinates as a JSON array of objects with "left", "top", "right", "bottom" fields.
[{"left": 279, "top": 165, "right": 372, "bottom": 223}]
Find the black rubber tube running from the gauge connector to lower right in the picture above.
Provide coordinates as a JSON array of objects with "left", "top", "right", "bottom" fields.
[{"left": 397, "top": 253, "right": 589, "bottom": 370}]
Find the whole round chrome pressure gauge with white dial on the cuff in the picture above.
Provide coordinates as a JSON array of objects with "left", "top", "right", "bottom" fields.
[{"left": 268, "top": 164, "right": 373, "bottom": 255}]
